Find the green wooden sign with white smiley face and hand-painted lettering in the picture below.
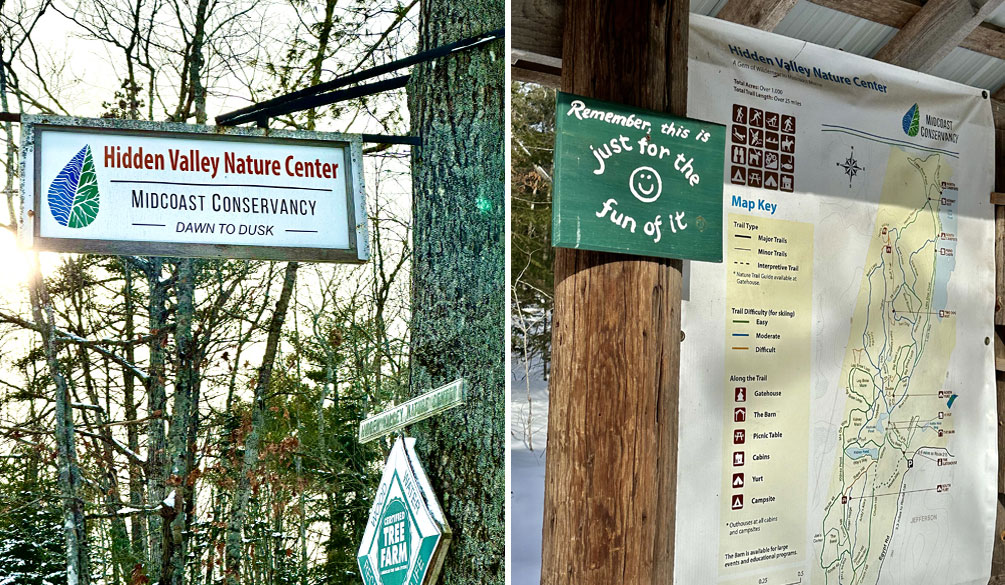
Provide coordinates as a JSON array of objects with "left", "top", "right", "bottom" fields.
[{"left": 552, "top": 92, "right": 726, "bottom": 262}]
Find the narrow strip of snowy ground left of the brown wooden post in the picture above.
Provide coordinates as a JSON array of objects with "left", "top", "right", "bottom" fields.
[{"left": 510, "top": 359, "right": 548, "bottom": 585}]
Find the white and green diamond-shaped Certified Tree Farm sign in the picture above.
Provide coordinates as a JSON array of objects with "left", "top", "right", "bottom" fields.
[{"left": 357, "top": 438, "right": 450, "bottom": 585}]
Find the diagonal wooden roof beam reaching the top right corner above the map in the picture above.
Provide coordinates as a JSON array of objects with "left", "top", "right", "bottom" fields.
[{"left": 873, "top": 0, "right": 1005, "bottom": 71}]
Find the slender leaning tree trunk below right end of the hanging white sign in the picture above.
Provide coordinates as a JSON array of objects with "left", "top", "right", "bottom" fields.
[{"left": 225, "top": 262, "right": 297, "bottom": 585}]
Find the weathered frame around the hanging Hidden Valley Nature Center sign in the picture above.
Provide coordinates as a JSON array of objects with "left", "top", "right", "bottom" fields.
[{"left": 21, "top": 116, "right": 369, "bottom": 263}]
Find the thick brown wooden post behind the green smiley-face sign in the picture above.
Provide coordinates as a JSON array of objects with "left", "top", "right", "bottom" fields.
[{"left": 542, "top": 0, "right": 689, "bottom": 585}]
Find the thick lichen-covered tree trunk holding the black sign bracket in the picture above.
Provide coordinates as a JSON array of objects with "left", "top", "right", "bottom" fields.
[{"left": 408, "top": 0, "right": 507, "bottom": 585}]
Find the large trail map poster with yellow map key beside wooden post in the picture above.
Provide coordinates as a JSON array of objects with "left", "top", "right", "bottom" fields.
[{"left": 674, "top": 15, "right": 997, "bottom": 585}]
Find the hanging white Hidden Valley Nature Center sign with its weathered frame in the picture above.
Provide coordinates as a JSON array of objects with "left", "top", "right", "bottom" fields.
[{"left": 22, "top": 116, "right": 368, "bottom": 262}]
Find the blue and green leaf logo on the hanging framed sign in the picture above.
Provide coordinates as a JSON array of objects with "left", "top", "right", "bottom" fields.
[{"left": 48, "top": 145, "right": 101, "bottom": 228}]
